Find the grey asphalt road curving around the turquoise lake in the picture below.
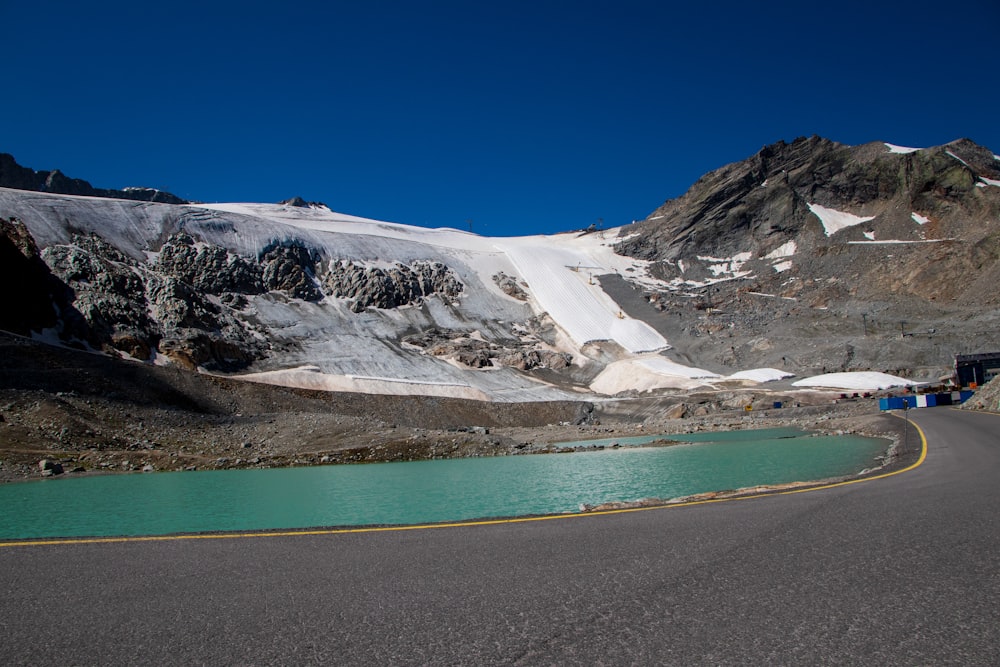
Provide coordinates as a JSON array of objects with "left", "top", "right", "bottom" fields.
[{"left": 0, "top": 408, "right": 1000, "bottom": 665}]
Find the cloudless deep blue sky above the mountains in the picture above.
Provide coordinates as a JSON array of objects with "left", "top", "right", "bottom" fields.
[{"left": 0, "top": 0, "right": 1000, "bottom": 236}]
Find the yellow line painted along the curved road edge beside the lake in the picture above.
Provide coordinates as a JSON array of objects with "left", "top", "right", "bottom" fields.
[{"left": 0, "top": 421, "right": 927, "bottom": 549}]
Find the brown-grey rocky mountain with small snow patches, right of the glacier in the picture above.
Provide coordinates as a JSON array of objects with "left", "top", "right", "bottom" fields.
[{"left": 616, "top": 137, "right": 1000, "bottom": 380}]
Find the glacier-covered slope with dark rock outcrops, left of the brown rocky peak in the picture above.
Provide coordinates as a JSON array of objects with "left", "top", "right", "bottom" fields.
[{"left": 0, "top": 183, "right": 669, "bottom": 401}]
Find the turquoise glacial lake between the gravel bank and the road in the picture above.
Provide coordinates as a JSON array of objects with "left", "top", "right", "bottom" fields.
[{"left": 0, "top": 428, "right": 889, "bottom": 539}]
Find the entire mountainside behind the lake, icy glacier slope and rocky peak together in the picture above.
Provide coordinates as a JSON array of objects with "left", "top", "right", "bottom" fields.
[{"left": 0, "top": 138, "right": 1000, "bottom": 402}]
